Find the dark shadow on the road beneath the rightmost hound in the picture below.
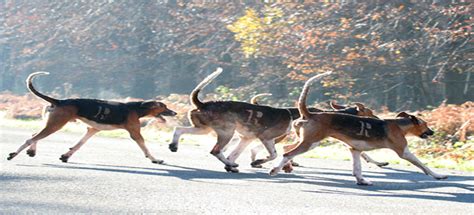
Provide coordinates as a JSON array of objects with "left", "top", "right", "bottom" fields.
[{"left": 296, "top": 167, "right": 474, "bottom": 203}]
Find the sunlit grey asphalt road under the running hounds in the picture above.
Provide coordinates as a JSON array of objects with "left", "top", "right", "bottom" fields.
[{"left": 0, "top": 127, "right": 474, "bottom": 214}]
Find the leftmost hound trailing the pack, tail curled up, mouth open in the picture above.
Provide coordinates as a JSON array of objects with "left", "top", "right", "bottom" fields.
[{"left": 7, "top": 72, "right": 176, "bottom": 164}]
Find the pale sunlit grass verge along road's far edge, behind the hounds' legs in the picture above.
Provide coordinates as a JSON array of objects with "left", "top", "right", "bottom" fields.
[{"left": 0, "top": 115, "right": 474, "bottom": 172}]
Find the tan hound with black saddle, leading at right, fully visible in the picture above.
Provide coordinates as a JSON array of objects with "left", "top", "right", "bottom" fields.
[{"left": 270, "top": 73, "right": 447, "bottom": 185}]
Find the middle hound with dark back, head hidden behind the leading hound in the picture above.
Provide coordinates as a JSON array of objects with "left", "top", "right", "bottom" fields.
[{"left": 169, "top": 68, "right": 316, "bottom": 172}]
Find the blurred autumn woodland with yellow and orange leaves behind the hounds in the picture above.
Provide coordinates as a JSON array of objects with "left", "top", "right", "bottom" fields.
[{"left": 0, "top": 0, "right": 474, "bottom": 110}]
